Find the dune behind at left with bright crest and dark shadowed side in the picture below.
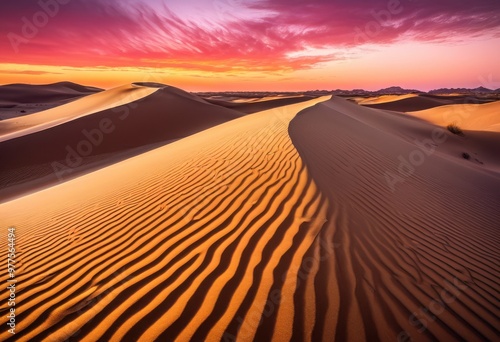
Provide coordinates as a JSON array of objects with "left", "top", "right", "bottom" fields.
[{"left": 0, "top": 85, "right": 241, "bottom": 200}]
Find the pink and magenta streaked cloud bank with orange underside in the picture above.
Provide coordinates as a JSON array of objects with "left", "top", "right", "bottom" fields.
[{"left": 0, "top": 0, "right": 500, "bottom": 72}]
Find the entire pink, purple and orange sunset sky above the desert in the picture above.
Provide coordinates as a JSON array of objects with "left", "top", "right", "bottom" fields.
[{"left": 0, "top": 0, "right": 500, "bottom": 91}]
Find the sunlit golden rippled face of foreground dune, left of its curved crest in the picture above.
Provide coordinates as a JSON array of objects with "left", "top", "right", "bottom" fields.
[{"left": 0, "top": 93, "right": 327, "bottom": 341}]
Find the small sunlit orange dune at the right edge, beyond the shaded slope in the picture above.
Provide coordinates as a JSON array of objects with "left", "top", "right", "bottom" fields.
[{"left": 409, "top": 101, "right": 500, "bottom": 132}]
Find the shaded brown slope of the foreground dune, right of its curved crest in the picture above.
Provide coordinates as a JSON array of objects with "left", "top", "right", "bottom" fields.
[{"left": 290, "top": 98, "right": 500, "bottom": 341}]
